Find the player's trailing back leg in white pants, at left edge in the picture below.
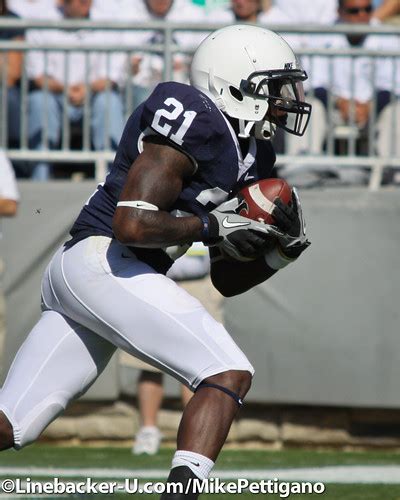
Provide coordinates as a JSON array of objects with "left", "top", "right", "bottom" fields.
[{"left": 0, "top": 311, "right": 115, "bottom": 449}]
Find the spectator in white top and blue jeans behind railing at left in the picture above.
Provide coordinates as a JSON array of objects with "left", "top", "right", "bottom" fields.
[{"left": 28, "top": 0, "right": 124, "bottom": 180}]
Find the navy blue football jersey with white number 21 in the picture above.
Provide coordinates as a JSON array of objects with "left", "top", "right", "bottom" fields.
[{"left": 68, "top": 82, "right": 275, "bottom": 272}]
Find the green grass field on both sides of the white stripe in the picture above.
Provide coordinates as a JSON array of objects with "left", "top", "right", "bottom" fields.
[{"left": 0, "top": 445, "right": 400, "bottom": 500}]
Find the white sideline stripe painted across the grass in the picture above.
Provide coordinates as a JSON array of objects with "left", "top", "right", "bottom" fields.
[{"left": 0, "top": 465, "right": 400, "bottom": 484}]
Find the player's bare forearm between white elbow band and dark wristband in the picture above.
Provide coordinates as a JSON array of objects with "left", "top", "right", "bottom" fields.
[{"left": 113, "top": 208, "right": 203, "bottom": 248}]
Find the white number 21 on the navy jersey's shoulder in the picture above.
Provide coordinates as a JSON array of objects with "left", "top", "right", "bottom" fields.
[{"left": 151, "top": 97, "right": 197, "bottom": 146}]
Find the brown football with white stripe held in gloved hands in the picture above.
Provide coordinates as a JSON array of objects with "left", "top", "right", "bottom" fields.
[{"left": 238, "top": 179, "right": 292, "bottom": 224}]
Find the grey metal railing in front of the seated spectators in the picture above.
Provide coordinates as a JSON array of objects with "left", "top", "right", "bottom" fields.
[{"left": 0, "top": 18, "right": 400, "bottom": 189}]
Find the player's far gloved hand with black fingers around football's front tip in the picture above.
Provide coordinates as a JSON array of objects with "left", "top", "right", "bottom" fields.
[{"left": 272, "top": 188, "right": 311, "bottom": 259}]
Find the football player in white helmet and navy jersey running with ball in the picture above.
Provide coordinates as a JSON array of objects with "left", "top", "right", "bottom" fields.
[{"left": 0, "top": 25, "right": 311, "bottom": 500}]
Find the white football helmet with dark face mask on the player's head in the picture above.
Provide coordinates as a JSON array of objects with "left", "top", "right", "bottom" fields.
[{"left": 190, "top": 24, "right": 311, "bottom": 139}]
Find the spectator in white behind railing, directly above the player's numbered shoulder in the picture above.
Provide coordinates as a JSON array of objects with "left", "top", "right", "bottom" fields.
[{"left": 123, "top": 0, "right": 206, "bottom": 109}]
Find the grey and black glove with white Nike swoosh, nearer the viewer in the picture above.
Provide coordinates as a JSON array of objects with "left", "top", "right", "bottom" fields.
[{"left": 201, "top": 198, "right": 284, "bottom": 261}]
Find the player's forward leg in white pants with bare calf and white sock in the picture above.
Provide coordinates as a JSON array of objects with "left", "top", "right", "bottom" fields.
[{"left": 43, "top": 237, "right": 253, "bottom": 496}]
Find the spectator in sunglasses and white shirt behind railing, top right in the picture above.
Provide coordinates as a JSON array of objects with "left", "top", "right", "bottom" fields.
[{"left": 334, "top": 0, "right": 400, "bottom": 156}]
